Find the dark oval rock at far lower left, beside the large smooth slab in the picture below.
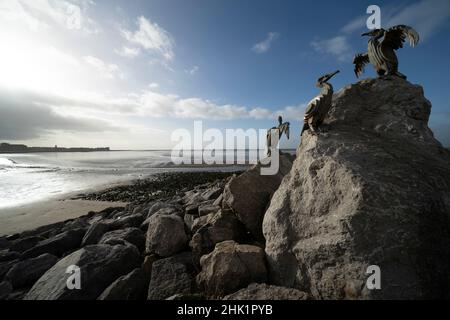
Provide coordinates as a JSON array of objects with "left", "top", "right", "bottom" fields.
[{"left": 5, "top": 253, "right": 58, "bottom": 289}]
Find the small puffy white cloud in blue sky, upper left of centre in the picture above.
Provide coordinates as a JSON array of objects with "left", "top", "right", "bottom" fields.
[{"left": 121, "top": 16, "right": 175, "bottom": 61}]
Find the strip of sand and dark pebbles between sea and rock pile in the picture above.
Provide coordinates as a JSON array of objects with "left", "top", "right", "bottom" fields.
[{"left": 0, "top": 170, "right": 241, "bottom": 236}]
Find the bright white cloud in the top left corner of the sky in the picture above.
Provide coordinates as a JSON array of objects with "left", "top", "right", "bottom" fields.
[{"left": 0, "top": 0, "right": 99, "bottom": 33}]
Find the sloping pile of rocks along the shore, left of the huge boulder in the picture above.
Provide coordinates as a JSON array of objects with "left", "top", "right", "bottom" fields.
[{"left": 0, "top": 160, "right": 298, "bottom": 300}]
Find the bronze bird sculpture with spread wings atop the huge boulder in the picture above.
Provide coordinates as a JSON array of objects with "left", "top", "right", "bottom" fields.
[{"left": 353, "top": 25, "right": 419, "bottom": 79}]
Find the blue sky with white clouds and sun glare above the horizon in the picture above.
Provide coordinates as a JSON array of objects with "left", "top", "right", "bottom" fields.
[{"left": 0, "top": 0, "right": 450, "bottom": 149}]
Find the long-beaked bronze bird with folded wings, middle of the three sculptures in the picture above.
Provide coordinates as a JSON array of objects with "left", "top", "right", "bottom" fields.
[{"left": 301, "top": 70, "right": 339, "bottom": 135}]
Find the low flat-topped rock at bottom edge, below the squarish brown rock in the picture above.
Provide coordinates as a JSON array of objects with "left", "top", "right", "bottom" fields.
[{"left": 223, "top": 283, "right": 308, "bottom": 300}]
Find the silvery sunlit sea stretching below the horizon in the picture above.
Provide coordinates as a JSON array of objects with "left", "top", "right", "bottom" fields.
[{"left": 0, "top": 150, "right": 264, "bottom": 209}]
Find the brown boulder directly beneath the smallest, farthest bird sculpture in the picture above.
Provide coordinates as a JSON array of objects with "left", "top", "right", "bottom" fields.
[{"left": 222, "top": 154, "right": 292, "bottom": 239}]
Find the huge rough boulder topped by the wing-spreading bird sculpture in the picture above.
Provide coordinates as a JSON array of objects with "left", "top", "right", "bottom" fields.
[{"left": 263, "top": 78, "right": 450, "bottom": 299}]
